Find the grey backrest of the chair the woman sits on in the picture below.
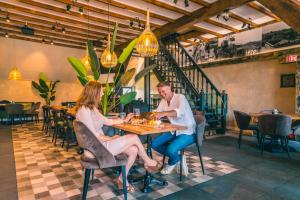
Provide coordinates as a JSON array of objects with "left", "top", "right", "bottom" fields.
[{"left": 73, "top": 120, "right": 116, "bottom": 168}]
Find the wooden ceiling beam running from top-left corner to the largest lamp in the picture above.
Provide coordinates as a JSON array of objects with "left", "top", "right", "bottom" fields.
[{"left": 0, "top": 0, "right": 139, "bottom": 36}]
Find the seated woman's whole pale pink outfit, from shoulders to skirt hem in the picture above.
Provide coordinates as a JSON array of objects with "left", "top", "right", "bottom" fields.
[{"left": 76, "top": 106, "right": 125, "bottom": 156}]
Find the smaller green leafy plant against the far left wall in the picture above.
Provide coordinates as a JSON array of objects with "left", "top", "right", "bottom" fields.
[{"left": 31, "top": 73, "right": 59, "bottom": 106}]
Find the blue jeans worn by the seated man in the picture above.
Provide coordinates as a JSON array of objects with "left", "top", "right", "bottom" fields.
[{"left": 151, "top": 132, "right": 196, "bottom": 165}]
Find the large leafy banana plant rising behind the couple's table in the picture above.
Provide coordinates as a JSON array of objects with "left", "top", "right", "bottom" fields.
[{"left": 68, "top": 23, "right": 153, "bottom": 115}]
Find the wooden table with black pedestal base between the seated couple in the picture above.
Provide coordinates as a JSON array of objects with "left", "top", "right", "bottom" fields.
[{"left": 113, "top": 123, "right": 187, "bottom": 193}]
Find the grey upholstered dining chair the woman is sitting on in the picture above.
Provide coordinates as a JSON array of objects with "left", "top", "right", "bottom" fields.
[{"left": 73, "top": 120, "right": 127, "bottom": 200}]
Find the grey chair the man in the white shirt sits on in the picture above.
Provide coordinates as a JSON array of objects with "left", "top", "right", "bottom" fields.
[{"left": 163, "top": 115, "right": 206, "bottom": 181}]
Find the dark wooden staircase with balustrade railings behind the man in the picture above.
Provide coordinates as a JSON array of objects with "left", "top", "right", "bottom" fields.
[{"left": 151, "top": 35, "right": 227, "bottom": 133}]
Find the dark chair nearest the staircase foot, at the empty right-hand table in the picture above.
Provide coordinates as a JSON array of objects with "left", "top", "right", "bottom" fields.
[{"left": 233, "top": 110, "right": 260, "bottom": 148}]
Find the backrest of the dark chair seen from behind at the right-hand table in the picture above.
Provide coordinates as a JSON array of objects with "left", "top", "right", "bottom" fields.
[{"left": 258, "top": 114, "right": 292, "bottom": 136}]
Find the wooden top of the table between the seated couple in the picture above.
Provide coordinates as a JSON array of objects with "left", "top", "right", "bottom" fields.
[{"left": 113, "top": 123, "right": 187, "bottom": 135}]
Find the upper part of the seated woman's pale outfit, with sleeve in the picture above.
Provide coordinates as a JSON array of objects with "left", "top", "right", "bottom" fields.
[{"left": 76, "top": 106, "right": 123, "bottom": 141}]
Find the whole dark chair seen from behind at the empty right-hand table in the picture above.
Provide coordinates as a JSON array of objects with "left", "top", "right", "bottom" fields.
[{"left": 258, "top": 114, "right": 292, "bottom": 158}]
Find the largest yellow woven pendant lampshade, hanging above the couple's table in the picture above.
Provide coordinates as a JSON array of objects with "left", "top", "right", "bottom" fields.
[{"left": 136, "top": 9, "right": 159, "bottom": 57}]
